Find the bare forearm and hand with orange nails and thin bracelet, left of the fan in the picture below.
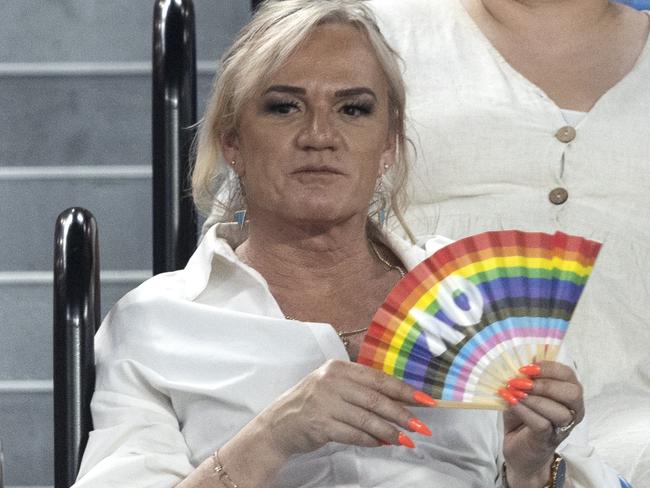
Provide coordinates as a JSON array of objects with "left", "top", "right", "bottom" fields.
[{"left": 178, "top": 360, "right": 436, "bottom": 488}]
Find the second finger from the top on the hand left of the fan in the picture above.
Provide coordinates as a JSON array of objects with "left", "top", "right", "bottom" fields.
[{"left": 341, "top": 384, "right": 431, "bottom": 436}]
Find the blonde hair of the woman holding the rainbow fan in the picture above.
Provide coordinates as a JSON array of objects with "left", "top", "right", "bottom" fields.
[{"left": 192, "top": 0, "right": 410, "bottom": 238}]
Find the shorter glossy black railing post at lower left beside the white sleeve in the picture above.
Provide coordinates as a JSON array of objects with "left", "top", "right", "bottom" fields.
[{"left": 52, "top": 208, "right": 101, "bottom": 488}]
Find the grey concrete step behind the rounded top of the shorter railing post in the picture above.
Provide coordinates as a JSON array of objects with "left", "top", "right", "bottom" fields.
[{"left": 0, "top": 173, "right": 152, "bottom": 271}]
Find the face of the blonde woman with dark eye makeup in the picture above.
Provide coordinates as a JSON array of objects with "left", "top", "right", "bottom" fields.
[{"left": 221, "top": 24, "right": 394, "bottom": 225}]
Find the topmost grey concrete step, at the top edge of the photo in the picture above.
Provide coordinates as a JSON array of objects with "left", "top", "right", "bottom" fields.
[{"left": 0, "top": 0, "right": 250, "bottom": 63}]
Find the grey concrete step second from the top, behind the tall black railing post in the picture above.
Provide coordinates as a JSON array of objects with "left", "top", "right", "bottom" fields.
[{"left": 0, "top": 68, "right": 214, "bottom": 167}]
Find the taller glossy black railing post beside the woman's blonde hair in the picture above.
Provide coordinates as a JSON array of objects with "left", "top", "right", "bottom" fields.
[{"left": 152, "top": 0, "right": 197, "bottom": 274}]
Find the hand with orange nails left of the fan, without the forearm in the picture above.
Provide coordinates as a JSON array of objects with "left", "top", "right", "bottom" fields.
[{"left": 259, "top": 360, "right": 435, "bottom": 458}]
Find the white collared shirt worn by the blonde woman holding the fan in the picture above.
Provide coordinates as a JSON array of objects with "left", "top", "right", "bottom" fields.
[{"left": 74, "top": 225, "right": 617, "bottom": 488}]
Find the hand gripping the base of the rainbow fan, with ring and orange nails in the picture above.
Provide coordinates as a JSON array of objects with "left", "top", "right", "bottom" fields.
[{"left": 502, "top": 361, "right": 585, "bottom": 488}]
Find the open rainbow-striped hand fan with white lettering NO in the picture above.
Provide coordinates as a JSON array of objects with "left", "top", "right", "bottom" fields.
[{"left": 357, "top": 230, "right": 600, "bottom": 410}]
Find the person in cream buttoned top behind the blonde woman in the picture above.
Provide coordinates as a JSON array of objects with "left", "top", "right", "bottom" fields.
[{"left": 370, "top": 0, "right": 650, "bottom": 487}]
